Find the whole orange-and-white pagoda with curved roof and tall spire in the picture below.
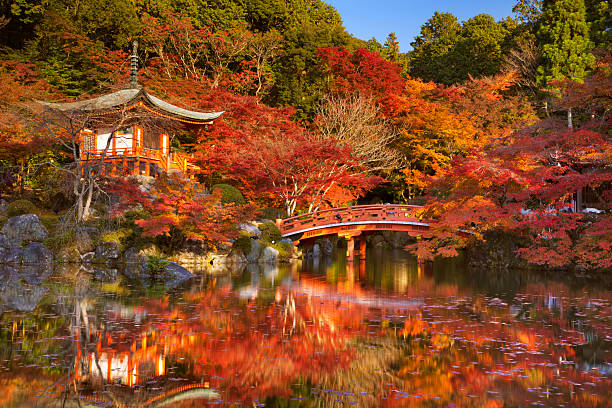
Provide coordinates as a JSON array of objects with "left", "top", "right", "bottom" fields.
[{"left": 41, "top": 42, "right": 223, "bottom": 177}]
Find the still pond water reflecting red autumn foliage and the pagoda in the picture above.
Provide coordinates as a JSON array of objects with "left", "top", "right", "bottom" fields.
[{"left": 0, "top": 250, "right": 612, "bottom": 408}]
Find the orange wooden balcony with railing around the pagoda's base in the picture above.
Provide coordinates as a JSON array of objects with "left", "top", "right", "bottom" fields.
[{"left": 81, "top": 146, "right": 197, "bottom": 177}]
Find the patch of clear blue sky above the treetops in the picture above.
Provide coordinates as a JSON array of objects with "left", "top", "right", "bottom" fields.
[{"left": 326, "top": 0, "right": 516, "bottom": 52}]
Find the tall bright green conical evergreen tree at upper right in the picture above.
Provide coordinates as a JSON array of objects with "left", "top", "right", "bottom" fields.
[{"left": 537, "top": 0, "right": 595, "bottom": 87}]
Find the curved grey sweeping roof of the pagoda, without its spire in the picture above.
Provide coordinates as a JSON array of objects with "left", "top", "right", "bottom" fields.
[{"left": 40, "top": 88, "right": 223, "bottom": 124}]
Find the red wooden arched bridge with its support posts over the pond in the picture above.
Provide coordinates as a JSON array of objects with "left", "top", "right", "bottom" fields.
[{"left": 277, "top": 204, "right": 429, "bottom": 260}]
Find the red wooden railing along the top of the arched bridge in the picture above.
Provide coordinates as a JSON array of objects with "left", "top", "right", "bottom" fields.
[{"left": 279, "top": 204, "right": 422, "bottom": 235}]
